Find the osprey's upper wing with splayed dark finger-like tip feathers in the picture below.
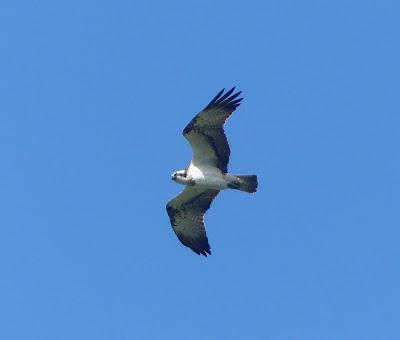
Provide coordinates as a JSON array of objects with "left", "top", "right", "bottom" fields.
[{"left": 183, "top": 88, "right": 243, "bottom": 173}]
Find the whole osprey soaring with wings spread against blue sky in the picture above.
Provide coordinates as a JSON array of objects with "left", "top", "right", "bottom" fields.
[{"left": 166, "top": 88, "right": 258, "bottom": 256}]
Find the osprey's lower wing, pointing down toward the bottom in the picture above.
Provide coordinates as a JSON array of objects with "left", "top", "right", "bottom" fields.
[{"left": 167, "top": 186, "right": 219, "bottom": 256}]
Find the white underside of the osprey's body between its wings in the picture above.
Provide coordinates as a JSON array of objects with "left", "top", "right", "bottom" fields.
[{"left": 188, "top": 163, "right": 230, "bottom": 190}]
